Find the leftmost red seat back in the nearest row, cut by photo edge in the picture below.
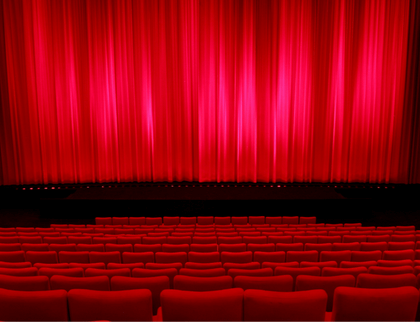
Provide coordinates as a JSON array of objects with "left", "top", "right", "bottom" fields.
[{"left": 0, "top": 289, "right": 68, "bottom": 321}]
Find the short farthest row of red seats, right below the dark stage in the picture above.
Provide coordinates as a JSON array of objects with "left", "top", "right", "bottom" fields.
[{"left": 95, "top": 216, "right": 316, "bottom": 225}]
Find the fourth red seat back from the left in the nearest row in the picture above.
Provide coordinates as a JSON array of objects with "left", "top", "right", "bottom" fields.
[{"left": 244, "top": 290, "right": 328, "bottom": 321}]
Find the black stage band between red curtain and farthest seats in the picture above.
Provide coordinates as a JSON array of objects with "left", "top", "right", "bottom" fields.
[{"left": 0, "top": 183, "right": 420, "bottom": 229}]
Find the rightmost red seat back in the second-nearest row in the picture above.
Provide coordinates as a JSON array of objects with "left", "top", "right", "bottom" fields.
[{"left": 356, "top": 274, "right": 417, "bottom": 288}]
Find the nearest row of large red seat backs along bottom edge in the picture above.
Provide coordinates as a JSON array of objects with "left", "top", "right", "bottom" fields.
[{"left": 0, "top": 286, "right": 419, "bottom": 321}]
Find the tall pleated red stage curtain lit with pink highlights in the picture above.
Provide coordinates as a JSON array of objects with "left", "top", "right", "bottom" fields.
[{"left": 0, "top": 0, "right": 420, "bottom": 185}]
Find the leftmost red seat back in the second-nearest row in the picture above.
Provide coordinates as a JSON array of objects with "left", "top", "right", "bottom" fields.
[{"left": 0, "top": 275, "right": 49, "bottom": 291}]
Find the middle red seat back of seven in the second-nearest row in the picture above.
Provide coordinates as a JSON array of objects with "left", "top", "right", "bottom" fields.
[{"left": 174, "top": 275, "right": 233, "bottom": 292}]
